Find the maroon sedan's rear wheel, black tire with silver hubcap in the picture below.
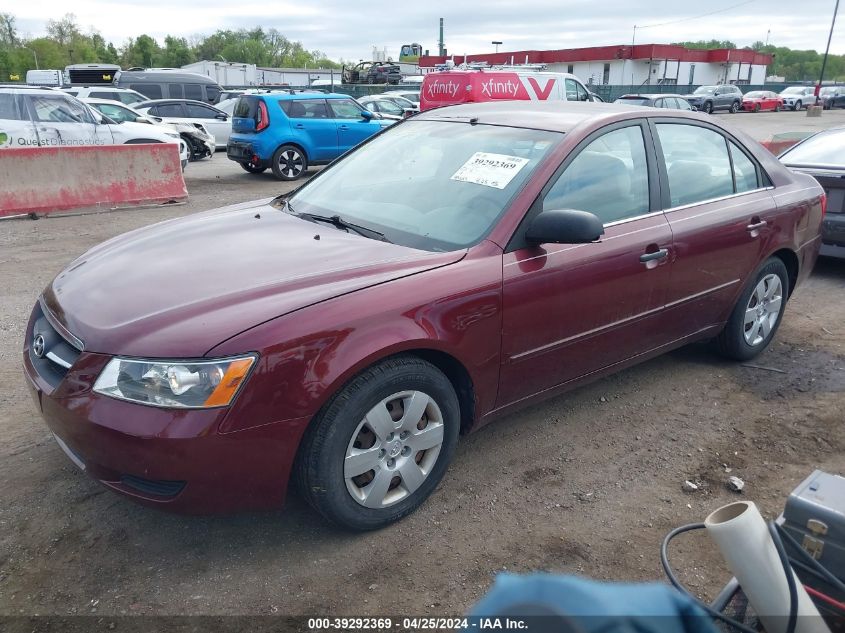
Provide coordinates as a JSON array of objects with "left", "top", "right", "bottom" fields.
[{"left": 716, "top": 257, "right": 789, "bottom": 361}]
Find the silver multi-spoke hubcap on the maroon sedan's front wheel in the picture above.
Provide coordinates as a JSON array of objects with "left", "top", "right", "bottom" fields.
[{"left": 343, "top": 391, "right": 443, "bottom": 508}]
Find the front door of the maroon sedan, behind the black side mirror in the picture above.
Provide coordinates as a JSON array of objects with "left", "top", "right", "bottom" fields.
[{"left": 498, "top": 122, "right": 672, "bottom": 406}]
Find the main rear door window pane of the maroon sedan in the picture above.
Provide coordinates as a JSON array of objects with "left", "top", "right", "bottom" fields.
[{"left": 656, "top": 123, "right": 734, "bottom": 207}]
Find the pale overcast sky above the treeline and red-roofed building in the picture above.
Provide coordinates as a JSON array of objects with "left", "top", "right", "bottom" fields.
[{"left": 0, "top": 0, "right": 845, "bottom": 61}]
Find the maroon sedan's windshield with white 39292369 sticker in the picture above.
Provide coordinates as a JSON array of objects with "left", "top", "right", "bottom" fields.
[{"left": 289, "top": 120, "right": 563, "bottom": 251}]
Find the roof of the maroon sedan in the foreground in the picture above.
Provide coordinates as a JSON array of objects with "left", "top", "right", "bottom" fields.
[{"left": 413, "top": 101, "right": 664, "bottom": 132}]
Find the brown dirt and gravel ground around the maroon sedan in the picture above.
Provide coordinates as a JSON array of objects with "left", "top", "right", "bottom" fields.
[{"left": 0, "top": 112, "right": 845, "bottom": 615}]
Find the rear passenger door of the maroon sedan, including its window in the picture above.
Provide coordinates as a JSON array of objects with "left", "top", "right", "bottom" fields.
[{"left": 652, "top": 118, "right": 774, "bottom": 338}]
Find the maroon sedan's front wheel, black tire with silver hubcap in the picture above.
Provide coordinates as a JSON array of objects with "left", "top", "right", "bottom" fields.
[{"left": 294, "top": 356, "right": 460, "bottom": 531}]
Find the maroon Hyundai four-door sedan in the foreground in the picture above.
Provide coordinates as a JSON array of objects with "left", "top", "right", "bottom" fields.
[{"left": 23, "top": 102, "right": 825, "bottom": 530}]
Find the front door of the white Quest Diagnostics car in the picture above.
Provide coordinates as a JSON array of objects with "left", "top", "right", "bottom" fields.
[{"left": 25, "top": 92, "right": 114, "bottom": 147}]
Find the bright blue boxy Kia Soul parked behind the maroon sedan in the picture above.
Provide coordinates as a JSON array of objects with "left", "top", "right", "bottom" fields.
[{"left": 226, "top": 92, "right": 393, "bottom": 180}]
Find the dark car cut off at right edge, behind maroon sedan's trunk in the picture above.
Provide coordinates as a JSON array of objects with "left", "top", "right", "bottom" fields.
[{"left": 780, "top": 127, "right": 845, "bottom": 257}]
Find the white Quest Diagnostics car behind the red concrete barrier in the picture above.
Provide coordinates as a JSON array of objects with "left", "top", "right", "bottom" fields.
[{"left": 0, "top": 86, "right": 188, "bottom": 169}]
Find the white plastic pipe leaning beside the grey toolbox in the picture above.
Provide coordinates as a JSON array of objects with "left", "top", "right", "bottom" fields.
[{"left": 704, "top": 501, "right": 830, "bottom": 633}]
